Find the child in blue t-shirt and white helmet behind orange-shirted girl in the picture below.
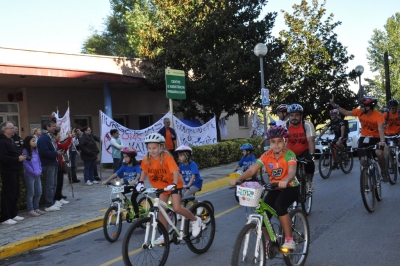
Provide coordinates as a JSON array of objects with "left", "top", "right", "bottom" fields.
[{"left": 175, "top": 145, "right": 203, "bottom": 198}]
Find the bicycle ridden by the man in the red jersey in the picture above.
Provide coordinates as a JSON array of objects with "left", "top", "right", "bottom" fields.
[{"left": 295, "top": 157, "right": 313, "bottom": 216}]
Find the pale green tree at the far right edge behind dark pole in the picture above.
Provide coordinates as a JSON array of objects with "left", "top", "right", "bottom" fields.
[{"left": 367, "top": 12, "right": 400, "bottom": 103}]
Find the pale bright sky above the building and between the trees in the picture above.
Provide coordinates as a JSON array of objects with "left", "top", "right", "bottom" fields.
[{"left": 0, "top": 0, "right": 400, "bottom": 91}]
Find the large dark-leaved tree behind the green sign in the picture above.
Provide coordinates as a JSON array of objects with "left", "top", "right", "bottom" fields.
[{"left": 134, "top": 0, "right": 282, "bottom": 140}]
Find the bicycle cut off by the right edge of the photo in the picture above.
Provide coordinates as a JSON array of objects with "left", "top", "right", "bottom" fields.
[{"left": 385, "top": 135, "right": 400, "bottom": 185}]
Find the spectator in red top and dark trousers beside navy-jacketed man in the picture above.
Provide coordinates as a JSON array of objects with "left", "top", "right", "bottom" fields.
[{"left": 54, "top": 130, "right": 72, "bottom": 207}]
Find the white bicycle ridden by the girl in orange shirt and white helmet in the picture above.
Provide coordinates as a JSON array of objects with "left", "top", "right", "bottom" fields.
[{"left": 122, "top": 188, "right": 215, "bottom": 265}]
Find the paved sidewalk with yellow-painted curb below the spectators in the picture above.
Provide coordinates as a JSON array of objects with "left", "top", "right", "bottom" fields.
[{"left": 0, "top": 162, "right": 237, "bottom": 259}]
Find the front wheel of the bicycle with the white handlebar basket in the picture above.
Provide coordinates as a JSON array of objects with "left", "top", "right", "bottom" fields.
[{"left": 231, "top": 223, "right": 267, "bottom": 266}]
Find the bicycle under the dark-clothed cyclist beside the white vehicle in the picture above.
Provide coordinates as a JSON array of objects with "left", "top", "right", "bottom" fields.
[{"left": 318, "top": 139, "right": 353, "bottom": 179}]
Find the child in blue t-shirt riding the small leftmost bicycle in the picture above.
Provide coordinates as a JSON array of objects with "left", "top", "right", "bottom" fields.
[{"left": 103, "top": 147, "right": 142, "bottom": 218}]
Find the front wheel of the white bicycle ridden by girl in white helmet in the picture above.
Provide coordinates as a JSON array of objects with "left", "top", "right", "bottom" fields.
[{"left": 122, "top": 217, "right": 170, "bottom": 266}]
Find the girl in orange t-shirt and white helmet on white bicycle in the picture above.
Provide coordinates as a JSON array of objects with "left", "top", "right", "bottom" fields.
[{"left": 136, "top": 133, "right": 201, "bottom": 245}]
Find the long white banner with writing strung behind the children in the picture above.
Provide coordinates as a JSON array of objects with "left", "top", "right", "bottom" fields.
[{"left": 99, "top": 111, "right": 217, "bottom": 163}]
